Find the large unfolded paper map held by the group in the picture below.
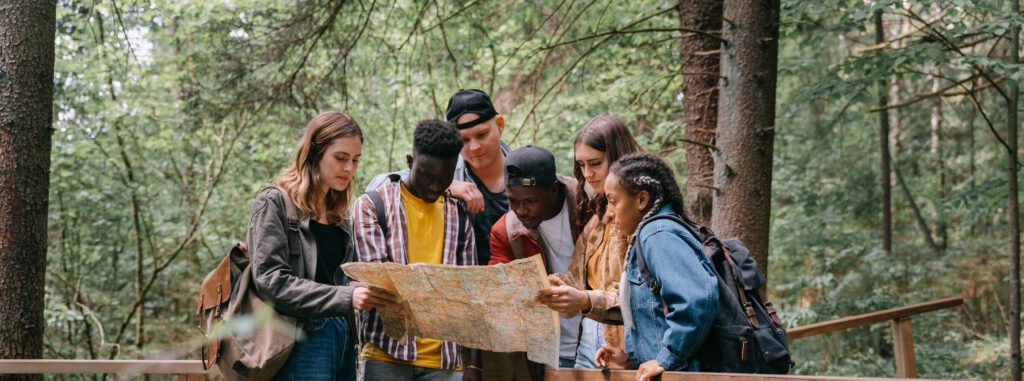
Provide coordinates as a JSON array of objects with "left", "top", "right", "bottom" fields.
[{"left": 341, "top": 255, "right": 560, "bottom": 367}]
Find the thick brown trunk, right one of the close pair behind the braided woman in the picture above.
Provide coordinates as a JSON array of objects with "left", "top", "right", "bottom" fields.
[{"left": 712, "top": 0, "right": 779, "bottom": 274}]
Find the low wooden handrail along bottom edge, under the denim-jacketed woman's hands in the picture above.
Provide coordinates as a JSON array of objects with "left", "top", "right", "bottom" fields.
[{"left": 544, "top": 369, "right": 950, "bottom": 381}]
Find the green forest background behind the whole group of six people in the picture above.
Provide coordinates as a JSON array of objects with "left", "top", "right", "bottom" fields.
[{"left": 9, "top": 0, "right": 1024, "bottom": 379}]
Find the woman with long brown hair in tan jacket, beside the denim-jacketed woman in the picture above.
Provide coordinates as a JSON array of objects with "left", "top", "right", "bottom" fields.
[{"left": 539, "top": 115, "right": 640, "bottom": 369}]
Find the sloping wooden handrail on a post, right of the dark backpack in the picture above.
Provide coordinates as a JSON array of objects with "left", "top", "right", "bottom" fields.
[{"left": 786, "top": 298, "right": 964, "bottom": 340}]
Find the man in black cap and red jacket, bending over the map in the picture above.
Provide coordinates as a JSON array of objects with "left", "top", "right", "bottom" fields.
[{"left": 482, "top": 145, "right": 581, "bottom": 380}]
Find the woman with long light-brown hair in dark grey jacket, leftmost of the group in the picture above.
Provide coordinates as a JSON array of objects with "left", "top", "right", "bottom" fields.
[{"left": 247, "top": 112, "right": 394, "bottom": 380}]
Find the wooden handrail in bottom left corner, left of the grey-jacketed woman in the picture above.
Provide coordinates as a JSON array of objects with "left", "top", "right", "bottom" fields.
[{"left": 0, "top": 359, "right": 207, "bottom": 375}]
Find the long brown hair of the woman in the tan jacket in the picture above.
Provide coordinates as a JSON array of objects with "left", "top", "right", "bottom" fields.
[{"left": 572, "top": 115, "right": 642, "bottom": 229}]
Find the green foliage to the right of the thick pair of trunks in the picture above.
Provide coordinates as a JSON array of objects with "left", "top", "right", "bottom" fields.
[{"left": 770, "top": 1, "right": 1021, "bottom": 379}]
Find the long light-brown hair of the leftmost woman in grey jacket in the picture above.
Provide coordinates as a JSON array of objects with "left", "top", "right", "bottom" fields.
[{"left": 278, "top": 112, "right": 364, "bottom": 224}]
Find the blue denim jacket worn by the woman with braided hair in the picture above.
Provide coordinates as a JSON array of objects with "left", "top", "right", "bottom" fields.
[{"left": 623, "top": 205, "right": 718, "bottom": 372}]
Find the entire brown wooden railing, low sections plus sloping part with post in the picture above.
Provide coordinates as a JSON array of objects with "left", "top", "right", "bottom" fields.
[{"left": 0, "top": 298, "right": 964, "bottom": 381}]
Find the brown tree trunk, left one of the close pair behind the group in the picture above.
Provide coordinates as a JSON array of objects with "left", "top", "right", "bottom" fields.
[{"left": 679, "top": 1, "right": 722, "bottom": 225}]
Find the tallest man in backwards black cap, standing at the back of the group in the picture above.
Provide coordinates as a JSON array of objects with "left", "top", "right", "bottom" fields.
[{"left": 367, "top": 89, "right": 512, "bottom": 264}]
